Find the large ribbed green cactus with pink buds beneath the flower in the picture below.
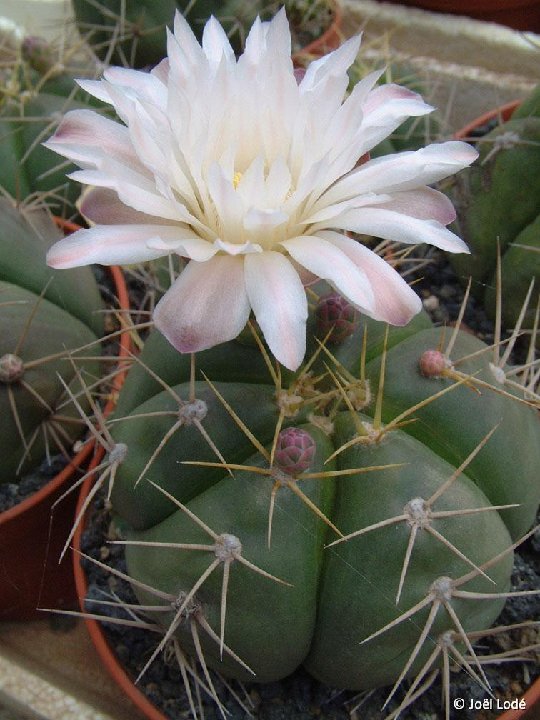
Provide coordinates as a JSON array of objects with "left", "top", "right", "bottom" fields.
[{"left": 95, "top": 286, "right": 540, "bottom": 708}]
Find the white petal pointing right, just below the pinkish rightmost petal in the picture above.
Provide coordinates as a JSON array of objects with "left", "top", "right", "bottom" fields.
[{"left": 326, "top": 207, "right": 469, "bottom": 253}]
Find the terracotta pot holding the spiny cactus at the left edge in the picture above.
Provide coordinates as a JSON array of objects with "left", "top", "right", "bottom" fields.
[{"left": 0, "top": 221, "right": 130, "bottom": 620}]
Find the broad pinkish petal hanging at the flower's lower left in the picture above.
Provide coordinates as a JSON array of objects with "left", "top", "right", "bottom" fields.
[{"left": 154, "top": 255, "right": 250, "bottom": 353}]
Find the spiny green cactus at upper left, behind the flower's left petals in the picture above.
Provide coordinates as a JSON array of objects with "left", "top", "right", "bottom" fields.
[{"left": 0, "top": 25, "right": 104, "bottom": 217}]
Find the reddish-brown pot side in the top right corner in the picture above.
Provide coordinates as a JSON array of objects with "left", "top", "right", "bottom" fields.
[{"left": 382, "top": 0, "right": 540, "bottom": 32}]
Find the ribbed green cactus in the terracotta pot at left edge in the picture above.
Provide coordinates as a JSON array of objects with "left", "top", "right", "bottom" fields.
[{"left": 0, "top": 198, "right": 103, "bottom": 482}]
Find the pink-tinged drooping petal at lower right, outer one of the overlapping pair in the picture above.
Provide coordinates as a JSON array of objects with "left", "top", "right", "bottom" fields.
[{"left": 321, "top": 232, "right": 422, "bottom": 326}]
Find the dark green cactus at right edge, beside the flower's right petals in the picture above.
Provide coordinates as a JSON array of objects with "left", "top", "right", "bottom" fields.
[{"left": 451, "top": 86, "right": 540, "bottom": 336}]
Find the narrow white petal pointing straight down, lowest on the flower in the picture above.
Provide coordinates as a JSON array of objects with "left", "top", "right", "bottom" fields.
[{"left": 244, "top": 252, "right": 308, "bottom": 370}]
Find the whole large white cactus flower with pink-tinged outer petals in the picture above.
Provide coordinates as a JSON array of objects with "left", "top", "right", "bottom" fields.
[{"left": 46, "top": 11, "right": 477, "bottom": 370}]
